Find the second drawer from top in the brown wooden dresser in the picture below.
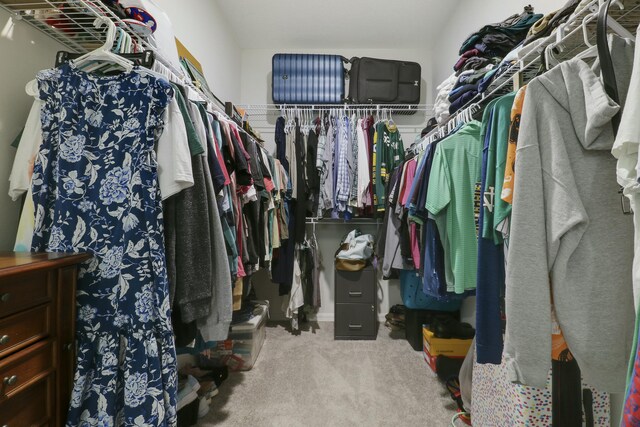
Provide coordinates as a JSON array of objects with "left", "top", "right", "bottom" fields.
[{"left": 0, "top": 304, "right": 52, "bottom": 357}]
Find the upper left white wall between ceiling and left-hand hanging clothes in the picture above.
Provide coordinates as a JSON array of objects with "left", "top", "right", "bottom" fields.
[{"left": 155, "top": 0, "right": 240, "bottom": 103}]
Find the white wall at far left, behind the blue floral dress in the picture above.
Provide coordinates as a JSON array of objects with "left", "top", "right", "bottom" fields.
[{"left": 0, "top": 10, "right": 64, "bottom": 251}]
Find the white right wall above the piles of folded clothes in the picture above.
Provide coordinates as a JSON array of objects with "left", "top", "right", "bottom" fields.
[{"left": 433, "top": 0, "right": 566, "bottom": 95}]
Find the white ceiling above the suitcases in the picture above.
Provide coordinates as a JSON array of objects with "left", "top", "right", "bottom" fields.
[{"left": 216, "top": 0, "right": 459, "bottom": 49}]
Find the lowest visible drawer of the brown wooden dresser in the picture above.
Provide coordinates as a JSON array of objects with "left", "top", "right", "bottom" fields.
[{"left": 0, "top": 376, "right": 54, "bottom": 427}]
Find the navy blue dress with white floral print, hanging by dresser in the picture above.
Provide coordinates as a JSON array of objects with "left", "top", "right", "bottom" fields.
[{"left": 32, "top": 65, "right": 177, "bottom": 426}]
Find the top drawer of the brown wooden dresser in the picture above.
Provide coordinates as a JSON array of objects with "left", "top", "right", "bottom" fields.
[{"left": 0, "top": 271, "right": 53, "bottom": 318}]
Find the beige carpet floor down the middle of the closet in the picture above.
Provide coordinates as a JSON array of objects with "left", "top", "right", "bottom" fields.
[{"left": 198, "top": 322, "right": 455, "bottom": 427}]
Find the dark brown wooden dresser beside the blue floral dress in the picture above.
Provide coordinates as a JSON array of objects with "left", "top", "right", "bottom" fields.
[{"left": 0, "top": 252, "right": 89, "bottom": 427}]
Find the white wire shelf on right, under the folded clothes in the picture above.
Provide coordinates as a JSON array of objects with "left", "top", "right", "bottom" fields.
[{"left": 425, "top": 0, "right": 640, "bottom": 139}]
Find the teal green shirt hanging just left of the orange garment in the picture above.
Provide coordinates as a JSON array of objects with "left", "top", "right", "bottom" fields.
[{"left": 482, "top": 93, "right": 516, "bottom": 245}]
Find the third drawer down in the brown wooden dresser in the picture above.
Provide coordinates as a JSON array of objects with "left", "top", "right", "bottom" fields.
[{"left": 0, "top": 340, "right": 56, "bottom": 401}]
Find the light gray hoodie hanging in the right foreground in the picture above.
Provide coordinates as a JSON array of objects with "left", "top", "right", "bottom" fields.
[{"left": 505, "top": 59, "right": 634, "bottom": 392}]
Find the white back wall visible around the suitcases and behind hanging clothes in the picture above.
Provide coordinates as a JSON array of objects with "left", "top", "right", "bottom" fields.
[{"left": 240, "top": 46, "right": 432, "bottom": 321}]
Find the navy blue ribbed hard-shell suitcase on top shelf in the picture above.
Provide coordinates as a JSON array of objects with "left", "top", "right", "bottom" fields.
[{"left": 272, "top": 53, "right": 346, "bottom": 104}]
